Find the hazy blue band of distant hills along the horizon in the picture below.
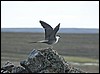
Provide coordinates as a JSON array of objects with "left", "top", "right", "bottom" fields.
[{"left": 1, "top": 28, "right": 99, "bottom": 33}]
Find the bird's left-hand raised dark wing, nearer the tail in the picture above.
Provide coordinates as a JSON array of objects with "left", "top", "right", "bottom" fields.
[{"left": 40, "top": 20, "right": 53, "bottom": 40}]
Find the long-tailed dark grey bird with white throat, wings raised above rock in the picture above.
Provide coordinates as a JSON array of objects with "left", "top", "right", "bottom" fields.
[{"left": 30, "top": 20, "right": 60, "bottom": 47}]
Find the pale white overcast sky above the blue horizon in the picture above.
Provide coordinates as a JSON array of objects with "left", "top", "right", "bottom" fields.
[{"left": 1, "top": 1, "right": 99, "bottom": 29}]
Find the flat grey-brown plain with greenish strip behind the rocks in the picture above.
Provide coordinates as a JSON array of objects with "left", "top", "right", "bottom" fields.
[{"left": 1, "top": 32, "right": 99, "bottom": 73}]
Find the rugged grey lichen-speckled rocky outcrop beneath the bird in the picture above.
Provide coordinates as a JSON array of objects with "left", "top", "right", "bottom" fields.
[{"left": 1, "top": 48, "right": 86, "bottom": 73}]
